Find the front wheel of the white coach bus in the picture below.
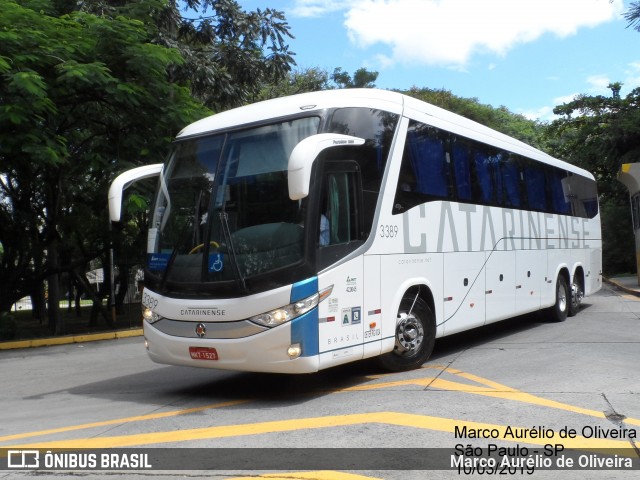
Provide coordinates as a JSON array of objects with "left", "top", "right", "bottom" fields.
[{"left": 380, "top": 296, "right": 436, "bottom": 372}]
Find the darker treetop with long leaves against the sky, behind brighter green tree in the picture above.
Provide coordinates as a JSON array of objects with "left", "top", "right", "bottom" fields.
[{"left": 81, "top": 0, "right": 295, "bottom": 111}]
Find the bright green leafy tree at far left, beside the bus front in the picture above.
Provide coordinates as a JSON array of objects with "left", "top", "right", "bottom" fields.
[{"left": 0, "top": 0, "right": 207, "bottom": 333}]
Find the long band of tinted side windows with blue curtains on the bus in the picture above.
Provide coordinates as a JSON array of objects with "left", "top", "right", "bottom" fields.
[{"left": 393, "top": 121, "right": 598, "bottom": 218}]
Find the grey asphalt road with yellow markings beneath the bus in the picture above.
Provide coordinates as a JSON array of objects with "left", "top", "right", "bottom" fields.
[{"left": 0, "top": 287, "right": 640, "bottom": 480}]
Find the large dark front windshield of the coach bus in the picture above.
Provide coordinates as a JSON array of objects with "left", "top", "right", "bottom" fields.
[{"left": 147, "top": 117, "right": 320, "bottom": 294}]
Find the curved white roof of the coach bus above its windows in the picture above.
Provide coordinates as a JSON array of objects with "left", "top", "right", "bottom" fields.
[{"left": 177, "top": 88, "right": 594, "bottom": 178}]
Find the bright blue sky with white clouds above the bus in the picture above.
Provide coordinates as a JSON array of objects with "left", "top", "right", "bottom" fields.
[{"left": 238, "top": 0, "right": 640, "bottom": 121}]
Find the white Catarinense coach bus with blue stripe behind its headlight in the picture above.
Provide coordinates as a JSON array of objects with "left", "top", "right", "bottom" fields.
[{"left": 109, "top": 89, "right": 602, "bottom": 373}]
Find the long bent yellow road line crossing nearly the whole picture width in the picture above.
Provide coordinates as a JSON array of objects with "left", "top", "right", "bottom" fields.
[{"left": 8, "top": 412, "right": 630, "bottom": 450}]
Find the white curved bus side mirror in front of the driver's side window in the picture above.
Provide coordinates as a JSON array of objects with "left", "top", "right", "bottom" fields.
[{"left": 288, "top": 133, "right": 365, "bottom": 200}]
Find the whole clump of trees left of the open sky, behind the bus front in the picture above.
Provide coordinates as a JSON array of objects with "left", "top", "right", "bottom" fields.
[{"left": 0, "top": 0, "right": 294, "bottom": 333}]
